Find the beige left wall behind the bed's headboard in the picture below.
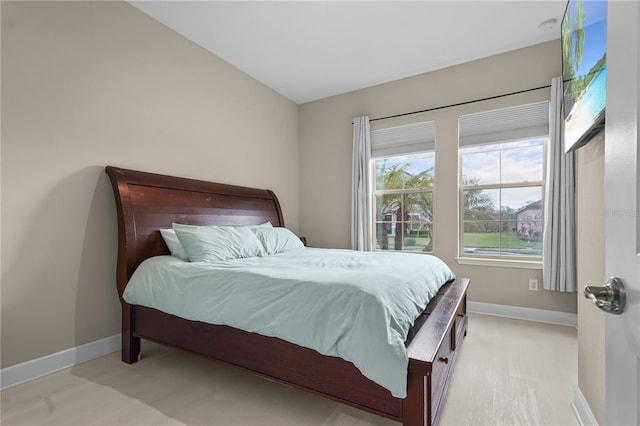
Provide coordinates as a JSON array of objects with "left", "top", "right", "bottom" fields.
[{"left": 1, "top": 1, "right": 299, "bottom": 367}]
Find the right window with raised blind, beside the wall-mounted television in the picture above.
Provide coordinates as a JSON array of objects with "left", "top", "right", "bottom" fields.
[{"left": 459, "top": 102, "right": 549, "bottom": 260}]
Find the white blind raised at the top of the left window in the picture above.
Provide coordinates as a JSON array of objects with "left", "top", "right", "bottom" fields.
[{"left": 371, "top": 121, "right": 435, "bottom": 158}]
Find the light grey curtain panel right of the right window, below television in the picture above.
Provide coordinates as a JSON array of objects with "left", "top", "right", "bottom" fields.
[{"left": 542, "top": 77, "right": 576, "bottom": 292}]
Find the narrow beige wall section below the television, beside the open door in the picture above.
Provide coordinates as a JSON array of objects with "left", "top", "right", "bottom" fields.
[{"left": 576, "top": 132, "right": 606, "bottom": 424}]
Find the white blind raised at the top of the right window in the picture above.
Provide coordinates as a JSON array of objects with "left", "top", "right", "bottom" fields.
[{"left": 458, "top": 101, "right": 549, "bottom": 147}]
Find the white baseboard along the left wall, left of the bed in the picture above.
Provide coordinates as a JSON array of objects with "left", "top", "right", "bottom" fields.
[{"left": 0, "top": 334, "right": 122, "bottom": 390}]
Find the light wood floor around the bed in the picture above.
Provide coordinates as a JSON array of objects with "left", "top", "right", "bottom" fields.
[{"left": 0, "top": 314, "right": 578, "bottom": 426}]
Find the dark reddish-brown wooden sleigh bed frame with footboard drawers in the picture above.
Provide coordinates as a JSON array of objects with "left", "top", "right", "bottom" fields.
[{"left": 106, "top": 166, "right": 469, "bottom": 426}]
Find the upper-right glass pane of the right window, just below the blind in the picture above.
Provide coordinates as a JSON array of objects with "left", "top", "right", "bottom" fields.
[{"left": 501, "top": 144, "right": 544, "bottom": 183}]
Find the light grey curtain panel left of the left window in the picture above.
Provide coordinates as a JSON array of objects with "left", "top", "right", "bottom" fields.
[{"left": 351, "top": 116, "right": 373, "bottom": 251}]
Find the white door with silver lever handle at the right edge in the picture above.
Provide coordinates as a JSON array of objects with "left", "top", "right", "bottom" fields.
[{"left": 605, "top": 0, "right": 640, "bottom": 426}]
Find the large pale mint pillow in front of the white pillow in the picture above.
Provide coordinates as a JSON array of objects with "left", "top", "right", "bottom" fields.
[{"left": 173, "top": 223, "right": 267, "bottom": 262}]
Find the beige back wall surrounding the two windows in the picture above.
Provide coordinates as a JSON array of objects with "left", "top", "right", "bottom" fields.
[{"left": 300, "top": 41, "right": 576, "bottom": 312}]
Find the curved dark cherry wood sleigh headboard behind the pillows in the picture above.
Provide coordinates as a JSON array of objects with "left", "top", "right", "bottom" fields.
[{"left": 106, "top": 166, "right": 284, "bottom": 296}]
